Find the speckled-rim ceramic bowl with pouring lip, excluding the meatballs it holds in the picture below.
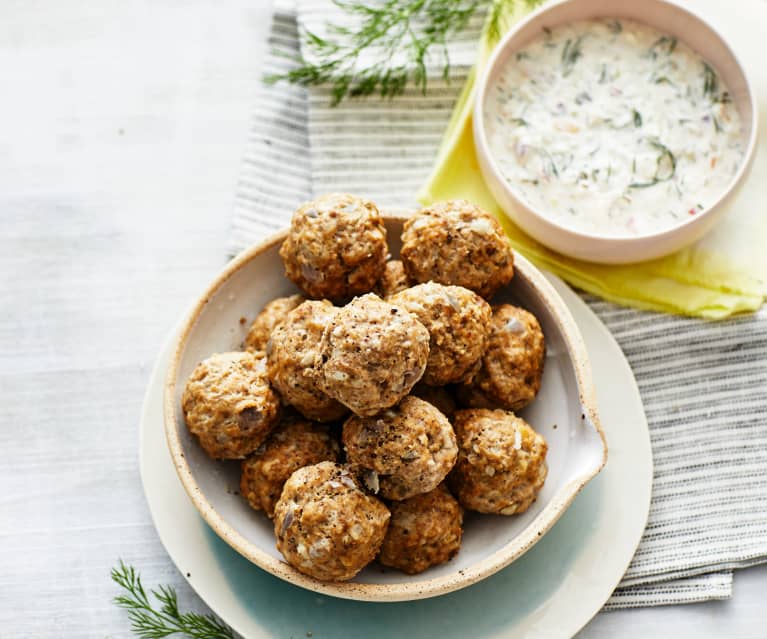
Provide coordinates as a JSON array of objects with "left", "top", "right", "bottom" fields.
[{"left": 164, "top": 216, "right": 607, "bottom": 601}]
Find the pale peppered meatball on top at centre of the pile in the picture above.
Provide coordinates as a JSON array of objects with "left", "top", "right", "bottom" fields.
[{"left": 317, "top": 293, "right": 429, "bottom": 416}]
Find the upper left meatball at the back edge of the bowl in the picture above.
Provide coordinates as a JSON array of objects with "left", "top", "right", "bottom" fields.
[{"left": 280, "top": 193, "right": 388, "bottom": 301}]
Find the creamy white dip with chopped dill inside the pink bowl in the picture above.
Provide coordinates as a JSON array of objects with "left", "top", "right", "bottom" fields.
[{"left": 485, "top": 19, "right": 744, "bottom": 237}]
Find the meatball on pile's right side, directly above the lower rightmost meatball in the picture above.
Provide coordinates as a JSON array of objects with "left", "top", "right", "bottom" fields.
[{"left": 459, "top": 304, "right": 546, "bottom": 411}]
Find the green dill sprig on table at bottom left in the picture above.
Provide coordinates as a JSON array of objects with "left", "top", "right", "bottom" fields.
[{"left": 111, "top": 560, "right": 235, "bottom": 639}]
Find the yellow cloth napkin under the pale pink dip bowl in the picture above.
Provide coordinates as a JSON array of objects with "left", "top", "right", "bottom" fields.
[{"left": 418, "top": 0, "right": 767, "bottom": 319}]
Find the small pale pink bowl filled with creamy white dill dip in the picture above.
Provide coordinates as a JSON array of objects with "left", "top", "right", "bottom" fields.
[{"left": 474, "top": 0, "right": 757, "bottom": 264}]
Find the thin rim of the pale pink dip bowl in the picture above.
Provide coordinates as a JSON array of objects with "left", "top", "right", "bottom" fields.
[{"left": 473, "top": 0, "right": 759, "bottom": 247}]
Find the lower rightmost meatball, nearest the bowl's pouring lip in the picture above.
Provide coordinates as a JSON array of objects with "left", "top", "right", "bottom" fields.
[{"left": 449, "top": 408, "right": 548, "bottom": 515}]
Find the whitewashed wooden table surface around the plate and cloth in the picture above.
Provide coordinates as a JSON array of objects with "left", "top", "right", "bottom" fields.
[{"left": 0, "top": 0, "right": 767, "bottom": 639}]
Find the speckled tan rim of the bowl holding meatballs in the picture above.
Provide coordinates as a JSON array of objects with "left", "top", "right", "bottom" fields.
[{"left": 163, "top": 213, "right": 607, "bottom": 602}]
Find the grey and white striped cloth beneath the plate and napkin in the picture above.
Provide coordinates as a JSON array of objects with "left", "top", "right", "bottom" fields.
[{"left": 231, "top": 0, "right": 767, "bottom": 609}]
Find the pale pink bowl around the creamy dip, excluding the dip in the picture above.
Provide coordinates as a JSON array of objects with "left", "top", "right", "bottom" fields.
[{"left": 474, "top": 0, "right": 758, "bottom": 264}]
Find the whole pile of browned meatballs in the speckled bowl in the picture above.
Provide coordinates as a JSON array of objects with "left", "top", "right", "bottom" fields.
[{"left": 182, "top": 194, "right": 547, "bottom": 581}]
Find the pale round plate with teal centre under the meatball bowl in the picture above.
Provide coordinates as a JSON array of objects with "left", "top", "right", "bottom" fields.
[{"left": 140, "top": 277, "right": 652, "bottom": 639}]
